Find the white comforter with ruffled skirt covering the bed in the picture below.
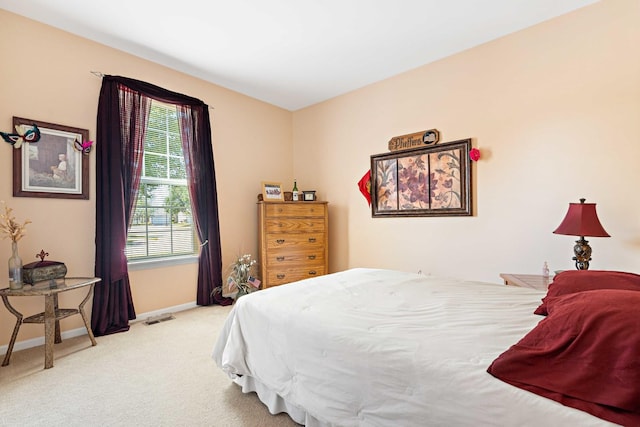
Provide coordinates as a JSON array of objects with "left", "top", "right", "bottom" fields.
[{"left": 213, "top": 268, "right": 640, "bottom": 427}]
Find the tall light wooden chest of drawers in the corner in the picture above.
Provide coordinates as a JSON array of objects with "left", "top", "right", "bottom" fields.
[{"left": 258, "top": 201, "right": 329, "bottom": 288}]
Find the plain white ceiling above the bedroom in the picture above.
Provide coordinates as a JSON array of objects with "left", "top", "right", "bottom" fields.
[{"left": 0, "top": 0, "right": 597, "bottom": 111}]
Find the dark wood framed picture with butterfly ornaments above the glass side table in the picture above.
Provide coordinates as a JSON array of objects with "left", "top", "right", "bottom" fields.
[{"left": 13, "top": 117, "right": 89, "bottom": 200}]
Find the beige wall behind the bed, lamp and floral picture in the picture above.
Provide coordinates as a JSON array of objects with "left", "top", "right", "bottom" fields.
[{"left": 293, "top": 0, "right": 640, "bottom": 282}]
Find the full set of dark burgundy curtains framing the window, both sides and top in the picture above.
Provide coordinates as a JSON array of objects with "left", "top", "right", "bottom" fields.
[{"left": 91, "top": 76, "right": 231, "bottom": 336}]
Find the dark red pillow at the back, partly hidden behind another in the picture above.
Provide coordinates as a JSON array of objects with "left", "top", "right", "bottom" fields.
[{"left": 533, "top": 270, "right": 640, "bottom": 316}]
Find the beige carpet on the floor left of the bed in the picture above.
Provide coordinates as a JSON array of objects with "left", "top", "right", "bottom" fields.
[{"left": 0, "top": 306, "right": 298, "bottom": 427}]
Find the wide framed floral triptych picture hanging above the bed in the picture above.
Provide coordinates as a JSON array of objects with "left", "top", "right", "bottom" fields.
[{"left": 371, "top": 139, "right": 472, "bottom": 218}]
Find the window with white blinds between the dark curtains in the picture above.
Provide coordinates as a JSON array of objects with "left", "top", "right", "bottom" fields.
[{"left": 125, "top": 101, "right": 197, "bottom": 261}]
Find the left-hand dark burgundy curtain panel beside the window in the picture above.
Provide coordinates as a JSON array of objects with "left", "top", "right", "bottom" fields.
[{"left": 91, "top": 76, "right": 150, "bottom": 336}]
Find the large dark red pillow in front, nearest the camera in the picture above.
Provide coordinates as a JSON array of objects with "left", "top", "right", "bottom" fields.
[{"left": 488, "top": 289, "right": 640, "bottom": 426}]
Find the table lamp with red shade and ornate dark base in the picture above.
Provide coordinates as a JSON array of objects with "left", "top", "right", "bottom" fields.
[{"left": 553, "top": 199, "right": 611, "bottom": 270}]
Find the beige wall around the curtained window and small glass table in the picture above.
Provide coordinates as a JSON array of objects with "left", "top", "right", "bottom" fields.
[{"left": 0, "top": 10, "right": 293, "bottom": 346}]
